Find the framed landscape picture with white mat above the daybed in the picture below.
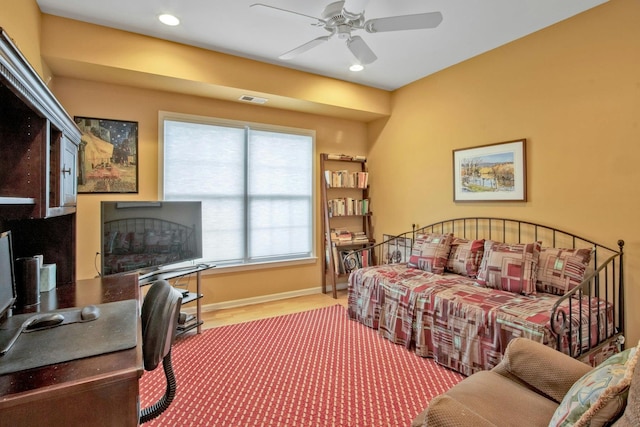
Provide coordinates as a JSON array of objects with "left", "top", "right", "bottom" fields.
[{"left": 453, "top": 139, "right": 527, "bottom": 202}]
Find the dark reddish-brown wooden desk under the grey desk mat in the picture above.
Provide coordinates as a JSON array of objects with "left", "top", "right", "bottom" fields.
[{"left": 0, "top": 275, "right": 143, "bottom": 427}]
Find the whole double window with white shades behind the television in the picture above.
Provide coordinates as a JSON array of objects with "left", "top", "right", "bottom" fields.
[{"left": 160, "top": 113, "right": 314, "bottom": 266}]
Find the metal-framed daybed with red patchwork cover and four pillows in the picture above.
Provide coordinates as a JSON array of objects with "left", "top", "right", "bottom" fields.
[{"left": 344, "top": 218, "right": 624, "bottom": 375}]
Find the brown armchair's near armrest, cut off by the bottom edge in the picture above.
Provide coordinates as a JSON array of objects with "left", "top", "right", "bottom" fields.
[{"left": 418, "top": 394, "right": 496, "bottom": 427}]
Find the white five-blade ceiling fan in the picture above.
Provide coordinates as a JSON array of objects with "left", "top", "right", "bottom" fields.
[{"left": 250, "top": 0, "right": 442, "bottom": 65}]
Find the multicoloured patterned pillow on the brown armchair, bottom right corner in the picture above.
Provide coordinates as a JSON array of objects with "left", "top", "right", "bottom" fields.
[{"left": 549, "top": 342, "right": 640, "bottom": 427}]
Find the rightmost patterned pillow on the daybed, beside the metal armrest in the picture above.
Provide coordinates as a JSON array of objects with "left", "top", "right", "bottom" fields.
[{"left": 536, "top": 248, "right": 592, "bottom": 295}]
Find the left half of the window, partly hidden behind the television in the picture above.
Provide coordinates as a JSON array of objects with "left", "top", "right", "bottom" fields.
[{"left": 163, "top": 120, "right": 245, "bottom": 262}]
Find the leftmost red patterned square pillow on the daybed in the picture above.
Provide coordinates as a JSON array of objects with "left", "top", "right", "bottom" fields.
[{"left": 408, "top": 233, "right": 453, "bottom": 274}]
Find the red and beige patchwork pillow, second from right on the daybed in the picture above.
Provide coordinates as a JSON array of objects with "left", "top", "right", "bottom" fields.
[{"left": 476, "top": 240, "right": 541, "bottom": 295}]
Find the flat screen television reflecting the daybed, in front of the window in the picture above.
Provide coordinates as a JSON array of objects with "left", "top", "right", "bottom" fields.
[{"left": 100, "top": 201, "right": 202, "bottom": 276}]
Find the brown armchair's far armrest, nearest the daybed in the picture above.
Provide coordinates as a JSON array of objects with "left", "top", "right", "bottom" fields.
[{"left": 493, "top": 338, "right": 592, "bottom": 403}]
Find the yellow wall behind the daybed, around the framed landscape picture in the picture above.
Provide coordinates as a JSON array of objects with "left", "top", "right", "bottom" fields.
[{"left": 369, "top": 0, "right": 640, "bottom": 343}]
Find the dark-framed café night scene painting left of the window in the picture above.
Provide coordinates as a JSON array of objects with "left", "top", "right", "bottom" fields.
[{"left": 73, "top": 116, "right": 138, "bottom": 193}]
